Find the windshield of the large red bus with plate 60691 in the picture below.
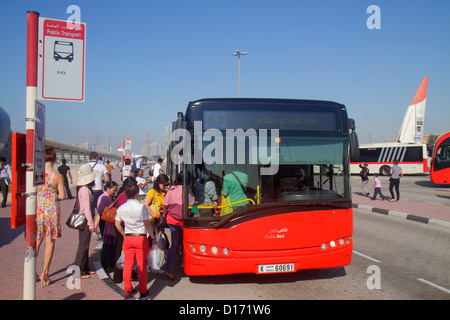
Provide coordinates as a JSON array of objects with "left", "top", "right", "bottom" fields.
[{"left": 185, "top": 132, "right": 351, "bottom": 227}]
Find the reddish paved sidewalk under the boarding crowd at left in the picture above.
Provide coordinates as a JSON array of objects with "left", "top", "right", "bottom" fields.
[{"left": 0, "top": 169, "right": 124, "bottom": 300}]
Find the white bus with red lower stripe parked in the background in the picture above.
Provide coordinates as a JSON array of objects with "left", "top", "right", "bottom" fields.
[{"left": 350, "top": 143, "right": 429, "bottom": 176}]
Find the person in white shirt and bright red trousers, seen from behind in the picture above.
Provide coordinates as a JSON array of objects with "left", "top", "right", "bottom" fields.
[{"left": 115, "top": 184, "right": 155, "bottom": 299}]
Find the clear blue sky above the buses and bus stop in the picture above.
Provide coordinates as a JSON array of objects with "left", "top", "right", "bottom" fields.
[{"left": 0, "top": 0, "right": 450, "bottom": 153}]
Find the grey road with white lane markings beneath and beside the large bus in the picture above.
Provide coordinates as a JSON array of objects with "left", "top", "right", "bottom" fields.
[{"left": 103, "top": 171, "right": 450, "bottom": 305}]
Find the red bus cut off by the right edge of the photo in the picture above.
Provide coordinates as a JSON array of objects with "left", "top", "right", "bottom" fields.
[{"left": 430, "top": 132, "right": 450, "bottom": 184}]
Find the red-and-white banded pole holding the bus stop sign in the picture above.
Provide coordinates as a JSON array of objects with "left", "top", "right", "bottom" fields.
[{"left": 23, "top": 10, "right": 39, "bottom": 300}]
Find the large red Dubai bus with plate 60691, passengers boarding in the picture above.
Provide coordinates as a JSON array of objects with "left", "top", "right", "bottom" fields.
[{"left": 168, "top": 98, "right": 357, "bottom": 276}]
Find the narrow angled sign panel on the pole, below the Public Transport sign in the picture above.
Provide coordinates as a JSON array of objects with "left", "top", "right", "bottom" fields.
[{"left": 33, "top": 101, "right": 45, "bottom": 186}]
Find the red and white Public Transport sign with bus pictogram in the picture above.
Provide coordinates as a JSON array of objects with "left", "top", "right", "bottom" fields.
[{"left": 37, "top": 18, "right": 86, "bottom": 102}]
